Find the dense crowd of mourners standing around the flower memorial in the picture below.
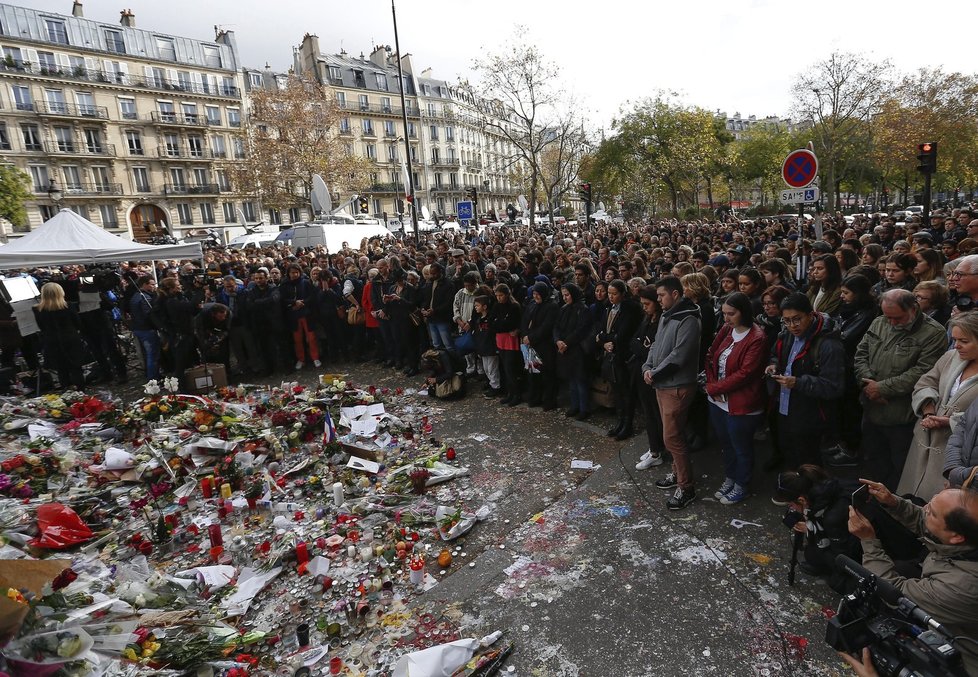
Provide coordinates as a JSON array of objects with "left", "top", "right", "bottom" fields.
[{"left": 1, "top": 207, "right": 978, "bottom": 674}]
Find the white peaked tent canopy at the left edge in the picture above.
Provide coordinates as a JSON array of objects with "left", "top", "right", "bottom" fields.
[{"left": 0, "top": 209, "right": 201, "bottom": 270}]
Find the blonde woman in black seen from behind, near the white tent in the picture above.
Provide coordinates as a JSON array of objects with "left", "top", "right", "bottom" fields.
[{"left": 33, "top": 282, "right": 85, "bottom": 390}]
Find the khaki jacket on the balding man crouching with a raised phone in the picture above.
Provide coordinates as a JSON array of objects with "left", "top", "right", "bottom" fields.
[{"left": 862, "top": 498, "right": 978, "bottom": 675}]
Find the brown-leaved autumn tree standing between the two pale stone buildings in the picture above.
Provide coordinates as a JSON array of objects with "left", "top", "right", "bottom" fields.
[{"left": 233, "top": 75, "right": 370, "bottom": 210}]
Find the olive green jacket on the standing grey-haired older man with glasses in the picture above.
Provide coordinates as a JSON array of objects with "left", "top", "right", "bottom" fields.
[{"left": 855, "top": 312, "right": 947, "bottom": 425}]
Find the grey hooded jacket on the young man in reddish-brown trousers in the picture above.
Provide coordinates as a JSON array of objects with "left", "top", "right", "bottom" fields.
[{"left": 642, "top": 298, "right": 700, "bottom": 390}]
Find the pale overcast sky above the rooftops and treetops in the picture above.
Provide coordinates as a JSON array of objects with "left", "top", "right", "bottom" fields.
[{"left": 17, "top": 0, "right": 978, "bottom": 127}]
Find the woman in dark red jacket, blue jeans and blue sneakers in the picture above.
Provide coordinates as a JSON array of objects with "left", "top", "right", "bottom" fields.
[{"left": 706, "top": 292, "right": 767, "bottom": 505}]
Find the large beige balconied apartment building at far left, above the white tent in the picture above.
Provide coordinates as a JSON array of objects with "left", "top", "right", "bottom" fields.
[{"left": 0, "top": 0, "right": 252, "bottom": 241}]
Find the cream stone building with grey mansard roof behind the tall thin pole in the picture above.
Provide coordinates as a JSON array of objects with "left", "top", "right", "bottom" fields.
[{"left": 294, "top": 34, "right": 517, "bottom": 217}]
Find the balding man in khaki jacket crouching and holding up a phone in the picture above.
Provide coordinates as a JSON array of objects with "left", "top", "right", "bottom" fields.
[{"left": 844, "top": 479, "right": 978, "bottom": 675}]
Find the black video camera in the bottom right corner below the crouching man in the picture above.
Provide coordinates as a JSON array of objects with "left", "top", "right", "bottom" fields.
[{"left": 825, "top": 555, "right": 968, "bottom": 677}]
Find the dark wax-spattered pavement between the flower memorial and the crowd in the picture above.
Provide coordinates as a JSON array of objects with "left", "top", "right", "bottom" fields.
[{"left": 154, "top": 366, "right": 842, "bottom": 676}]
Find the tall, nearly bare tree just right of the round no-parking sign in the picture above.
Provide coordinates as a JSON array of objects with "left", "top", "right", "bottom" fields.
[{"left": 792, "top": 52, "right": 892, "bottom": 209}]
